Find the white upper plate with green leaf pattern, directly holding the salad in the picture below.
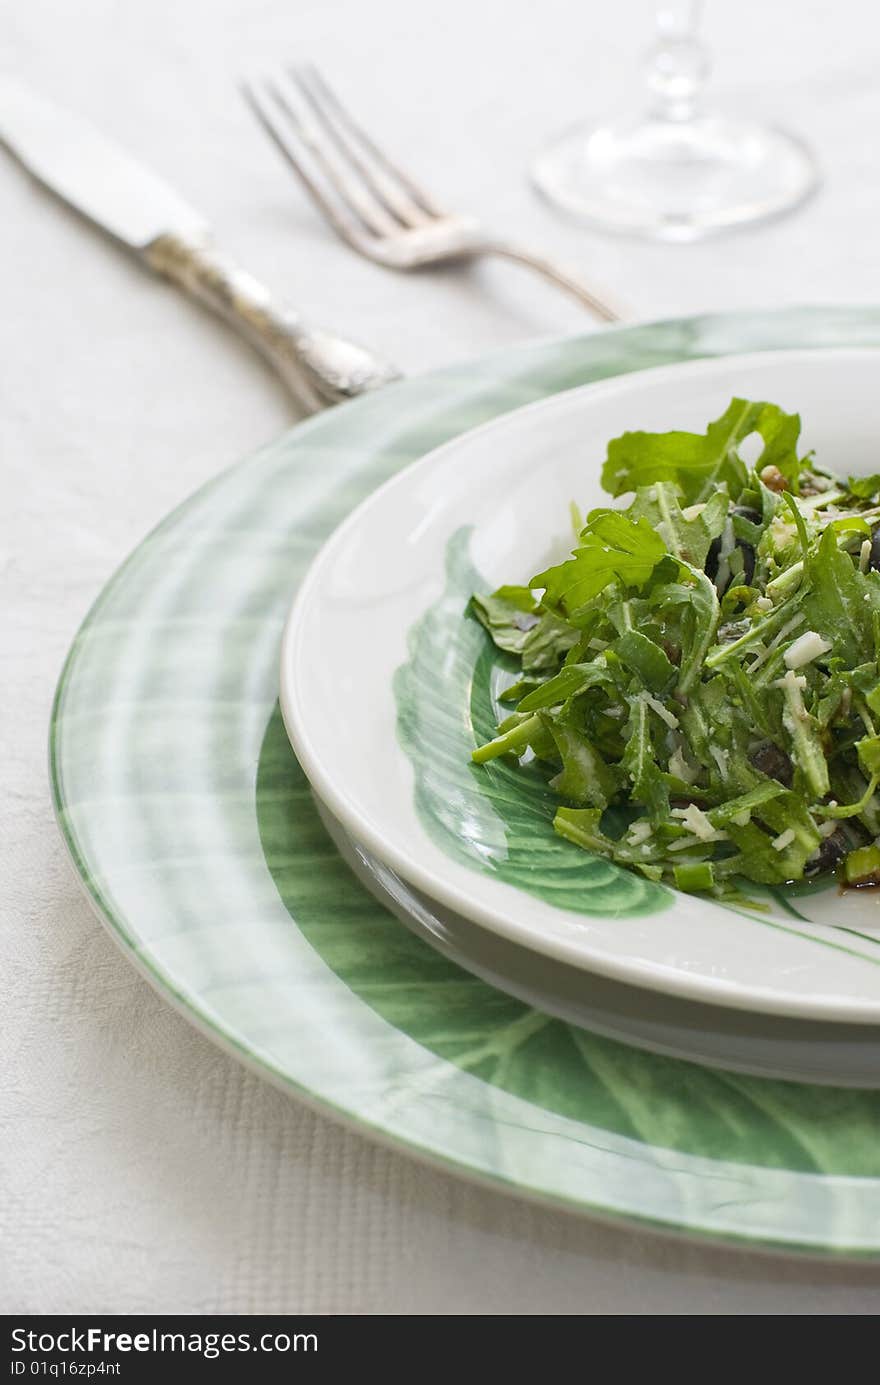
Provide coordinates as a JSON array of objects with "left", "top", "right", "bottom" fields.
[{"left": 281, "top": 348, "right": 880, "bottom": 1019}]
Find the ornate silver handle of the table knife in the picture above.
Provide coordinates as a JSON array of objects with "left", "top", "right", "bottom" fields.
[{"left": 144, "top": 233, "right": 399, "bottom": 413}]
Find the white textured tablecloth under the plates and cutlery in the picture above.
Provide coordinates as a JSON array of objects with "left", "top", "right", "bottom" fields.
[{"left": 0, "top": 0, "right": 880, "bottom": 1314}]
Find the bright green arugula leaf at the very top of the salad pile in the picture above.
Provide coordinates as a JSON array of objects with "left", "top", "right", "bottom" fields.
[{"left": 601, "top": 399, "right": 801, "bottom": 504}]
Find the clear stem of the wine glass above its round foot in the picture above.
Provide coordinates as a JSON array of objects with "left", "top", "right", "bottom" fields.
[{"left": 647, "top": 0, "right": 710, "bottom": 125}]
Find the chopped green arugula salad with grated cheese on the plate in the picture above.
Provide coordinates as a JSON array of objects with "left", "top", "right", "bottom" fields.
[{"left": 471, "top": 399, "right": 880, "bottom": 903}]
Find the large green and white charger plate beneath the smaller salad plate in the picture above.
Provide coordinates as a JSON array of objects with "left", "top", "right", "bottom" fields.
[{"left": 51, "top": 310, "right": 880, "bottom": 1256}]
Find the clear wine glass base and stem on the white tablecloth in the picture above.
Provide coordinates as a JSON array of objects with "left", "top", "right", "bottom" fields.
[{"left": 532, "top": 0, "right": 818, "bottom": 241}]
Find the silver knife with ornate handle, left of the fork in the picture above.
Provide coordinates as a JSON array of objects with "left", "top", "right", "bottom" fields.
[{"left": 0, "top": 78, "right": 398, "bottom": 411}]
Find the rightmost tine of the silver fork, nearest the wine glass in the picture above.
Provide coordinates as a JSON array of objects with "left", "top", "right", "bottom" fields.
[{"left": 287, "top": 64, "right": 443, "bottom": 230}]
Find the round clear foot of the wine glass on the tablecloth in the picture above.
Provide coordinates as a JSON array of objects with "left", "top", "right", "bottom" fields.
[{"left": 532, "top": 116, "right": 819, "bottom": 241}]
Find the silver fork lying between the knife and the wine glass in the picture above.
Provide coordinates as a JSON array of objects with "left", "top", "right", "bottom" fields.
[{"left": 243, "top": 65, "right": 619, "bottom": 323}]
